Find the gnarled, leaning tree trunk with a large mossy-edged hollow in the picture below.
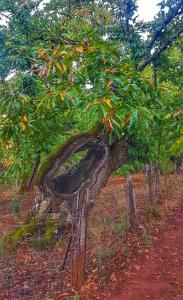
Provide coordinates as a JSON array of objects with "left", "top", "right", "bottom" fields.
[{"left": 30, "top": 127, "right": 128, "bottom": 223}]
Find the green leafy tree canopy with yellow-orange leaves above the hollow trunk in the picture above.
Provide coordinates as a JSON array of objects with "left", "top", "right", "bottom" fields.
[{"left": 0, "top": 0, "right": 182, "bottom": 180}]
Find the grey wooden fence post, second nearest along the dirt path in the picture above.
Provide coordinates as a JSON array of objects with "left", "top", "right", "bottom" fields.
[{"left": 126, "top": 175, "right": 137, "bottom": 230}]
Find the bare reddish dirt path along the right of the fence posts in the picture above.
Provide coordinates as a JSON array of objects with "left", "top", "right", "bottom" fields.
[{"left": 110, "top": 204, "right": 183, "bottom": 300}]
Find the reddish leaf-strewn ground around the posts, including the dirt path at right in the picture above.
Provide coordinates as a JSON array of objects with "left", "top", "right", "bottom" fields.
[{"left": 0, "top": 174, "right": 183, "bottom": 300}]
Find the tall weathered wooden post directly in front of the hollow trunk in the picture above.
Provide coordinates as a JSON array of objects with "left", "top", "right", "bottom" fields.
[{"left": 72, "top": 189, "right": 89, "bottom": 290}]
